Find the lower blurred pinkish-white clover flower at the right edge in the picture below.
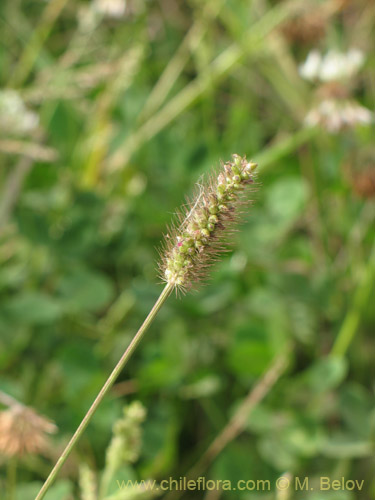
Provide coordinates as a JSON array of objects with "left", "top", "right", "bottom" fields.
[{"left": 305, "top": 99, "right": 375, "bottom": 133}]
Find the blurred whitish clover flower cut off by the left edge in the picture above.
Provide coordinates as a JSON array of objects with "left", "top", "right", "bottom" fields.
[{"left": 0, "top": 89, "right": 39, "bottom": 135}]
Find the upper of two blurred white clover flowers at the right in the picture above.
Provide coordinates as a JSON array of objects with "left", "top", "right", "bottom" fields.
[{"left": 299, "top": 49, "right": 365, "bottom": 82}]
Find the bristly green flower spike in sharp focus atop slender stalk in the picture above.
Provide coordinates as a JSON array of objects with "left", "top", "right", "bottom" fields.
[{"left": 160, "top": 154, "right": 257, "bottom": 291}]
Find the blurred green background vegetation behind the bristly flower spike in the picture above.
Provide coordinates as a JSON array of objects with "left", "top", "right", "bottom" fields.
[{"left": 0, "top": 0, "right": 375, "bottom": 500}]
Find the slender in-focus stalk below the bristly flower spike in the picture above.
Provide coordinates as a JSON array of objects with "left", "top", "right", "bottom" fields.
[{"left": 35, "top": 283, "right": 174, "bottom": 500}]
